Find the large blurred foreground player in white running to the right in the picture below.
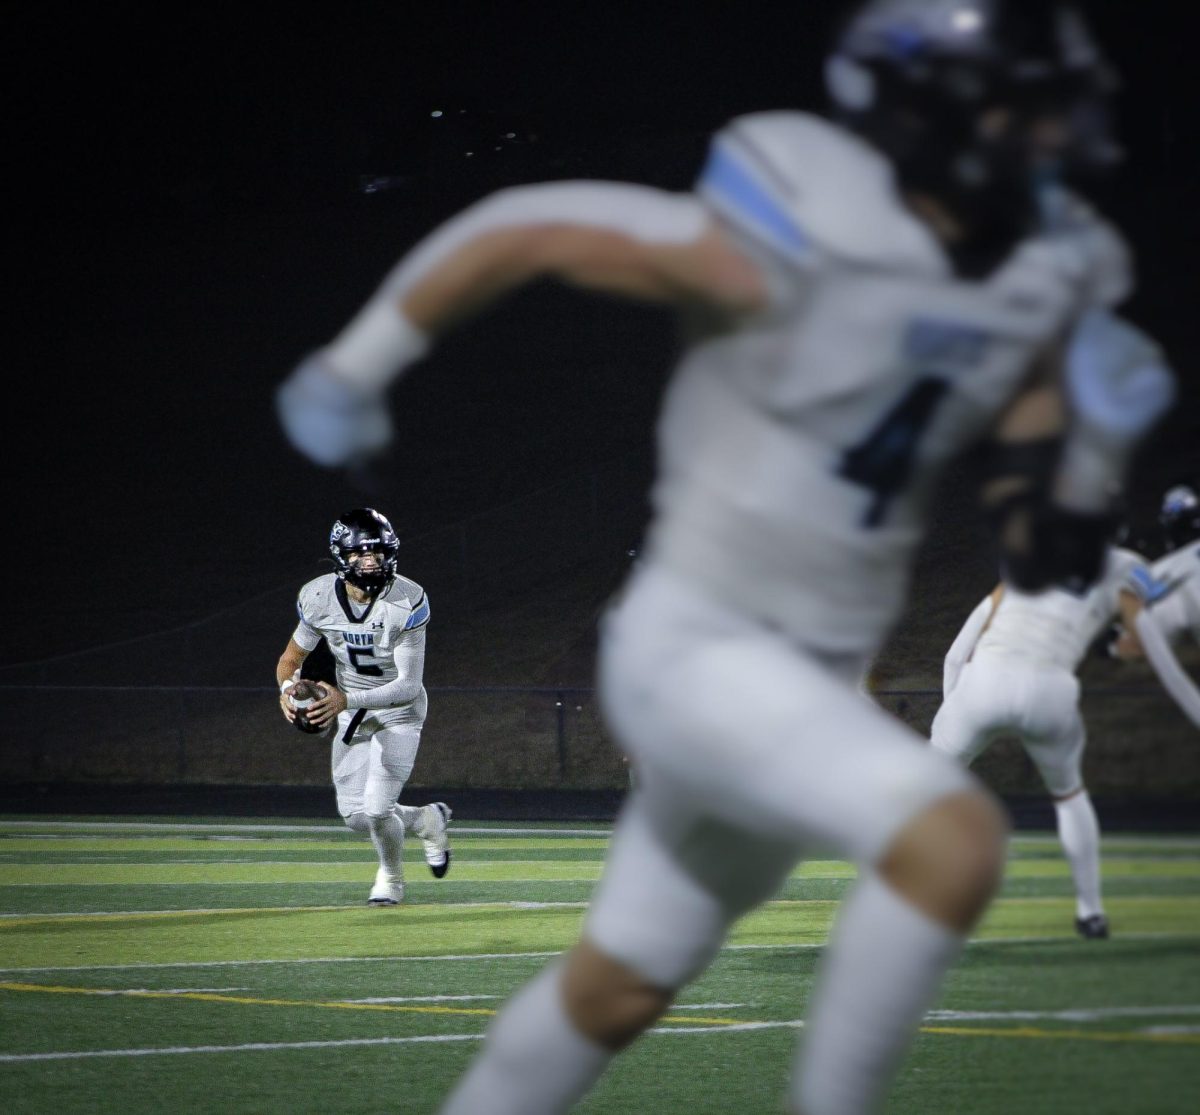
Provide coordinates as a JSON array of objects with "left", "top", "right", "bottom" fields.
[{"left": 278, "top": 0, "right": 1171, "bottom": 1115}]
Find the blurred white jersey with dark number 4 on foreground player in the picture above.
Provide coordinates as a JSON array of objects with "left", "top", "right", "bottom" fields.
[{"left": 647, "top": 113, "right": 1129, "bottom": 654}]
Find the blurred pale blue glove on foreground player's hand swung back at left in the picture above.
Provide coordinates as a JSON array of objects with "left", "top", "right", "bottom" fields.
[{"left": 275, "top": 352, "right": 392, "bottom": 468}]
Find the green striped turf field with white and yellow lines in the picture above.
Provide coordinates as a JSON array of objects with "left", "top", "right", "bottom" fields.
[{"left": 0, "top": 819, "right": 1200, "bottom": 1115}]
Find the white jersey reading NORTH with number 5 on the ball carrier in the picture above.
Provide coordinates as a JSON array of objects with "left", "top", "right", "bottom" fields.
[{"left": 292, "top": 573, "right": 430, "bottom": 693}]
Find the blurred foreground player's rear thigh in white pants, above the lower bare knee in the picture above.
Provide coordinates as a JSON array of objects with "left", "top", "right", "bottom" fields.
[{"left": 583, "top": 778, "right": 799, "bottom": 989}]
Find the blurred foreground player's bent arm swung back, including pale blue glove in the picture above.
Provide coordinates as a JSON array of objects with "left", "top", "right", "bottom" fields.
[{"left": 277, "top": 181, "right": 768, "bottom": 466}]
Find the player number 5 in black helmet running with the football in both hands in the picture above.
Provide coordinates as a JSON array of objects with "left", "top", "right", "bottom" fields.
[{"left": 275, "top": 508, "right": 450, "bottom": 906}]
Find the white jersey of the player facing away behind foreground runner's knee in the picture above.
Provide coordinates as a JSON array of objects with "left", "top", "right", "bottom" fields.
[{"left": 973, "top": 547, "right": 1146, "bottom": 672}]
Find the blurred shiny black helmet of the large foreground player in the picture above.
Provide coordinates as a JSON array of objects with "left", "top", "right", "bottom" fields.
[{"left": 826, "top": 0, "right": 1121, "bottom": 271}]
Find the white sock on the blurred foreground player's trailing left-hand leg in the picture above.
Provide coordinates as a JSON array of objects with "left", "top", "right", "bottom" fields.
[{"left": 440, "top": 960, "right": 613, "bottom": 1115}]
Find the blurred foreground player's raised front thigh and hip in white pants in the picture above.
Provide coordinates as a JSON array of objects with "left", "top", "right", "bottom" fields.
[{"left": 600, "top": 566, "right": 976, "bottom": 862}]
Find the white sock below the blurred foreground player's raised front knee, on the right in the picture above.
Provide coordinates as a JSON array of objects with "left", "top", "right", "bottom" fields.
[{"left": 791, "top": 875, "right": 962, "bottom": 1115}]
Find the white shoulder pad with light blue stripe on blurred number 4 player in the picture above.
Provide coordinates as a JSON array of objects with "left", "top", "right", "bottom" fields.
[{"left": 696, "top": 112, "right": 949, "bottom": 275}]
